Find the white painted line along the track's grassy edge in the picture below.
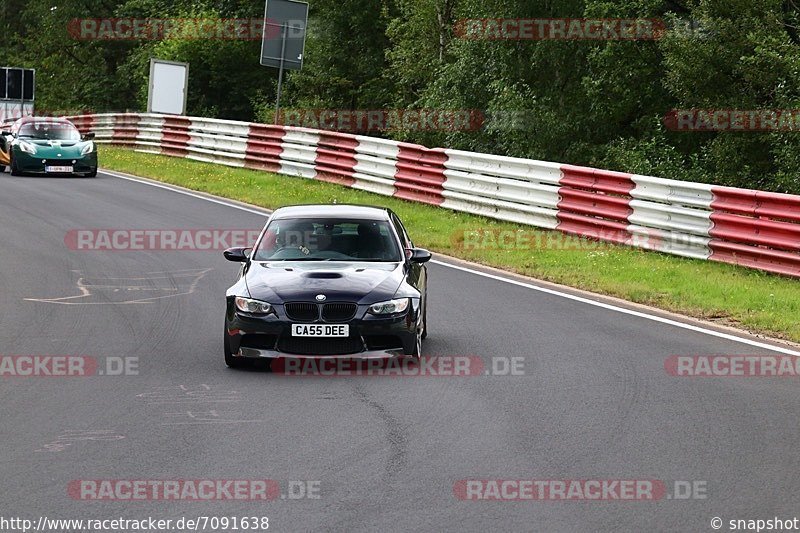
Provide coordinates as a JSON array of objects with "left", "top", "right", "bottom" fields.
[{"left": 101, "top": 170, "right": 800, "bottom": 357}]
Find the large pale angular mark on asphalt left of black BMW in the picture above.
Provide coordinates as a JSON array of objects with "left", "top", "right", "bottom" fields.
[{"left": 24, "top": 268, "right": 213, "bottom": 305}]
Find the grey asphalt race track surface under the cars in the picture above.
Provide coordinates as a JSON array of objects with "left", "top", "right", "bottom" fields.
[{"left": 0, "top": 173, "right": 800, "bottom": 531}]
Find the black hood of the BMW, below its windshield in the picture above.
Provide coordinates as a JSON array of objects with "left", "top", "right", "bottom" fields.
[{"left": 245, "top": 261, "right": 405, "bottom": 304}]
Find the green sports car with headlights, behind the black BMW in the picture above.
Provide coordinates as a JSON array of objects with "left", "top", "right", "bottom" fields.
[{"left": 0, "top": 117, "right": 97, "bottom": 177}]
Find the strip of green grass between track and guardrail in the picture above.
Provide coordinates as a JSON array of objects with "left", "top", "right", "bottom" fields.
[{"left": 101, "top": 146, "right": 800, "bottom": 342}]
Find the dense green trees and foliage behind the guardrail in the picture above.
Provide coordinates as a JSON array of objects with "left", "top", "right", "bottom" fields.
[{"left": 0, "top": 0, "right": 800, "bottom": 193}]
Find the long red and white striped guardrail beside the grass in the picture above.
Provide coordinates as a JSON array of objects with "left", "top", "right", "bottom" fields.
[{"left": 68, "top": 113, "right": 800, "bottom": 277}]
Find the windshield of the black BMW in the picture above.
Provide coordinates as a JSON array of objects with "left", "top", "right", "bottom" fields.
[{"left": 253, "top": 214, "right": 401, "bottom": 261}]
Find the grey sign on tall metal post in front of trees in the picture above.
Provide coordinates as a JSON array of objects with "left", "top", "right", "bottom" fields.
[{"left": 261, "top": 0, "right": 308, "bottom": 124}]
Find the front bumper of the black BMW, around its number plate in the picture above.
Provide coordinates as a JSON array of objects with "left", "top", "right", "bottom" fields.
[{"left": 225, "top": 296, "right": 419, "bottom": 359}]
